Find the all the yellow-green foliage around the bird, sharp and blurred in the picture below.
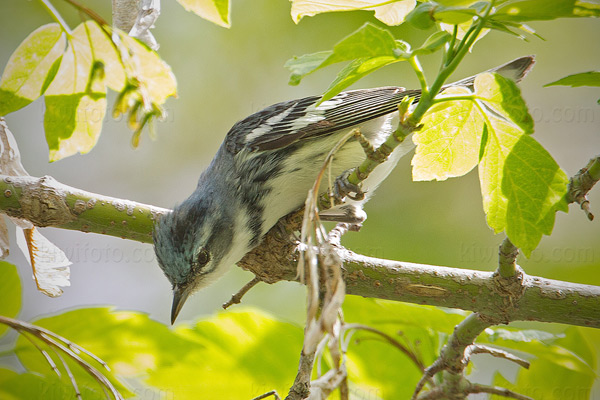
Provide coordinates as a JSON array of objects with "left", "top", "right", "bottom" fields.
[{"left": 0, "top": 0, "right": 600, "bottom": 399}]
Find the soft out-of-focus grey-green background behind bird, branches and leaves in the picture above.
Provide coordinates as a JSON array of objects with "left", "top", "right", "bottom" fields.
[{"left": 0, "top": 0, "right": 600, "bottom": 390}]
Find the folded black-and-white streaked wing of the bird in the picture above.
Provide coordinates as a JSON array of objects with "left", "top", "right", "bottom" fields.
[{"left": 225, "top": 87, "right": 420, "bottom": 153}]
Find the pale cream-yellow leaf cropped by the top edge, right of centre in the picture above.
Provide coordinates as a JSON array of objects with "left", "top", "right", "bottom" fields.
[{"left": 291, "top": 0, "right": 417, "bottom": 25}]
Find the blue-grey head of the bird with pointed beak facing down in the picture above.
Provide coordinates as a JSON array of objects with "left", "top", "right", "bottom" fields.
[{"left": 154, "top": 196, "right": 237, "bottom": 323}]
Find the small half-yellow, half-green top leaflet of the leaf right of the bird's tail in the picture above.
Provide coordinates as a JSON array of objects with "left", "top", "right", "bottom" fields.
[{"left": 475, "top": 72, "right": 533, "bottom": 134}]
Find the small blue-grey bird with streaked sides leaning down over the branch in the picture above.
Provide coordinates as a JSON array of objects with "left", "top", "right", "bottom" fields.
[{"left": 153, "top": 56, "right": 535, "bottom": 324}]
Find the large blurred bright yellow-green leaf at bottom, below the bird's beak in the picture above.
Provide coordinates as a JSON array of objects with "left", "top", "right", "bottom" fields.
[{"left": 148, "top": 310, "right": 302, "bottom": 400}]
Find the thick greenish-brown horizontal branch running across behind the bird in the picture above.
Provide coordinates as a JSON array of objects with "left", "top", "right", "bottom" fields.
[{"left": 0, "top": 175, "right": 600, "bottom": 327}]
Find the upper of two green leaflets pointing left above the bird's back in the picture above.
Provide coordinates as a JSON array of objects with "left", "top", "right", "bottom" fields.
[{"left": 285, "top": 23, "right": 407, "bottom": 85}]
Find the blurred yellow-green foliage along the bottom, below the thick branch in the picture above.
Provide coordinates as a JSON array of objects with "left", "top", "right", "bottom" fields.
[{"left": 0, "top": 263, "right": 597, "bottom": 400}]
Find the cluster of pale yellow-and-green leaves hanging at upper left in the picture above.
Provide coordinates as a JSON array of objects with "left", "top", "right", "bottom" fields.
[{"left": 0, "top": 20, "right": 176, "bottom": 161}]
